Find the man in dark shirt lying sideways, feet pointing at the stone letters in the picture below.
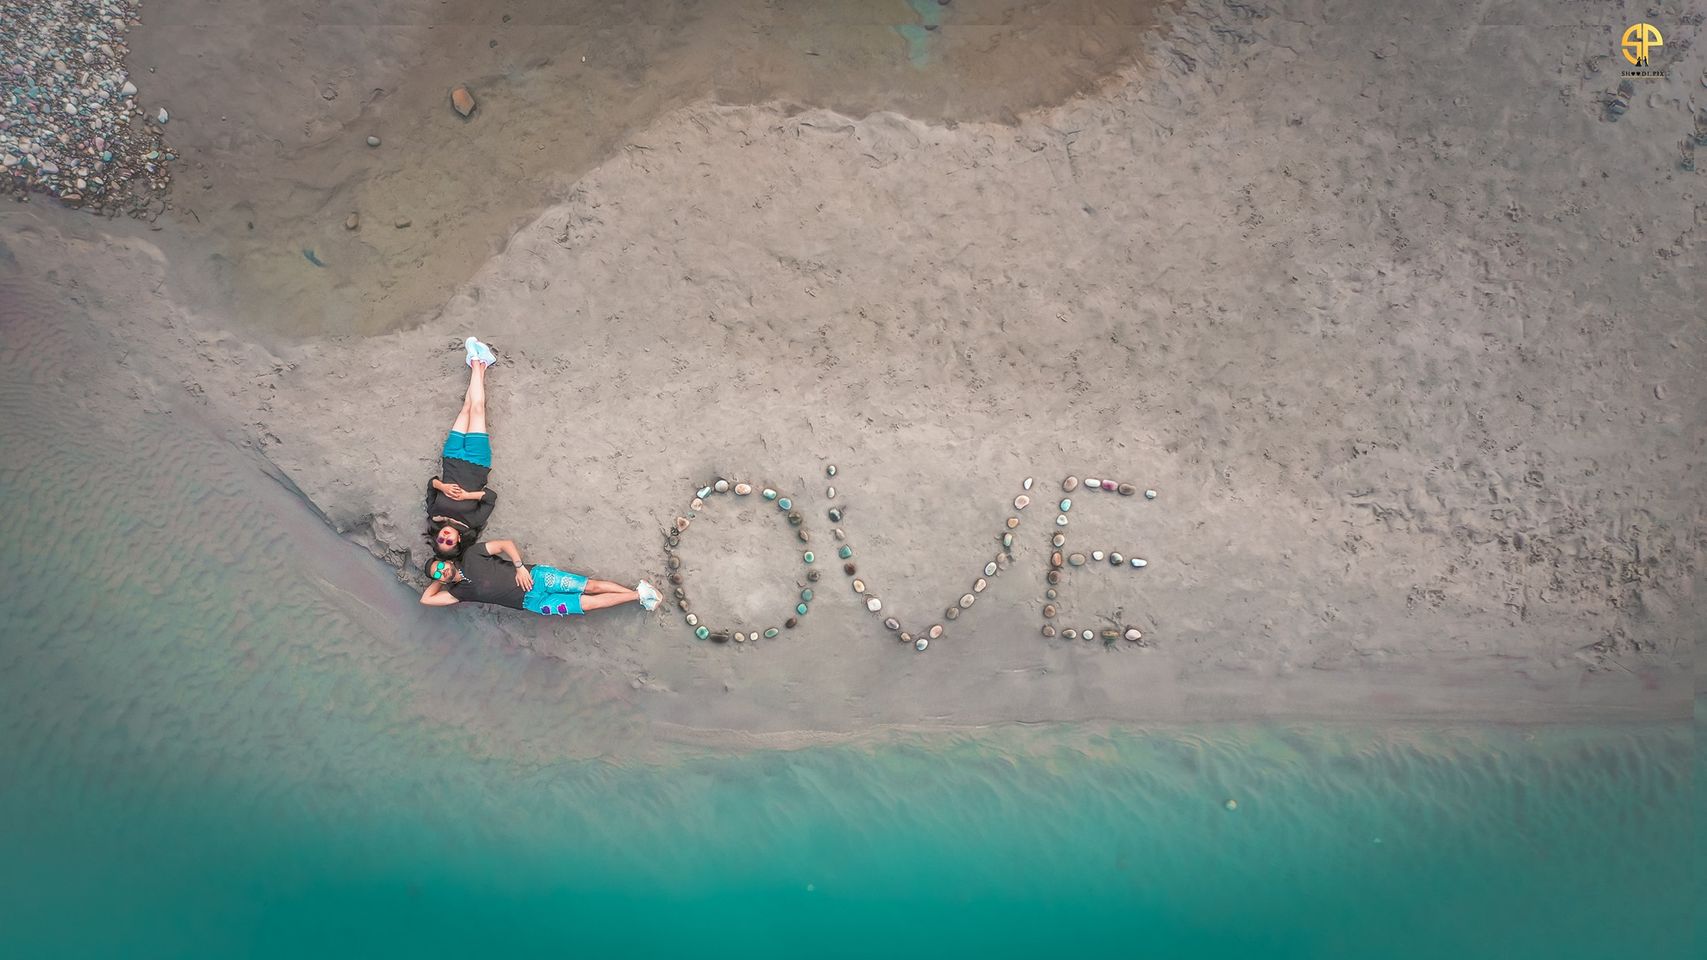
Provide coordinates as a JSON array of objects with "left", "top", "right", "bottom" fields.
[{"left": 422, "top": 540, "right": 659, "bottom": 617}]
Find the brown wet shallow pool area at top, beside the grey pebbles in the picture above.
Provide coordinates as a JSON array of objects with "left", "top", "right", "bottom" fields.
[{"left": 120, "top": 0, "right": 1161, "bottom": 338}]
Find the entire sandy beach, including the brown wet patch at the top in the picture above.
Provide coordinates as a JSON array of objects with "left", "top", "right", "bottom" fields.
[{"left": 0, "top": 0, "right": 1707, "bottom": 741}]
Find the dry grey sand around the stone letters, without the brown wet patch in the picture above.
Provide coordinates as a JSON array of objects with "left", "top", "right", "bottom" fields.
[{"left": 3, "top": 3, "right": 1707, "bottom": 733}]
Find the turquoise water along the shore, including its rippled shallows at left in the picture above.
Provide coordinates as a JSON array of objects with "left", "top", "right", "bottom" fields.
[{"left": 0, "top": 286, "right": 1700, "bottom": 958}]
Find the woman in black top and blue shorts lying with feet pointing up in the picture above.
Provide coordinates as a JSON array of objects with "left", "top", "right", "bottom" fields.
[{"left": 427, "top": 337, "right": 498, "bottom": 559}]
